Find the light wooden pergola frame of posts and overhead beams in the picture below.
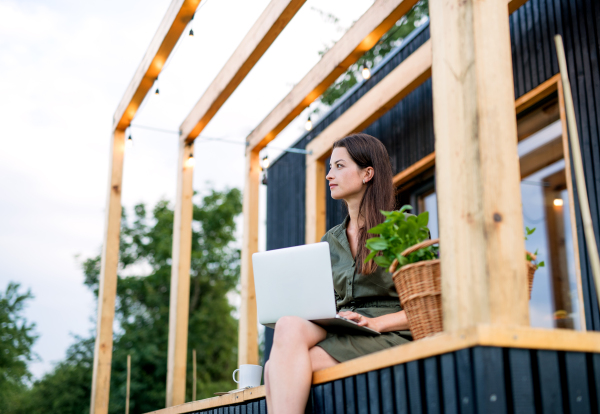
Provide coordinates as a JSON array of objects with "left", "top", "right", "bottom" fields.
[{"left": 90, "top": 0, "right": 600, "bottom": 414}]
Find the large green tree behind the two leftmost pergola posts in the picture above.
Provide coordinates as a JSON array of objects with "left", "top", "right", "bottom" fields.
[{"left": 12, "top": 189, "right": 242, "bottom": 414}]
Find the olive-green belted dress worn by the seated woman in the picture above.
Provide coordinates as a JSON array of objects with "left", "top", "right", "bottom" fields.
[{"left": 317, "top": 217, "right": 412, "bottom": 362}]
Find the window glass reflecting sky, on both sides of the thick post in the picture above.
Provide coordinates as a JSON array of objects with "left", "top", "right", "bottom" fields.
[{"left": 413, "top": 121, "right": 581, "bottom": 330}]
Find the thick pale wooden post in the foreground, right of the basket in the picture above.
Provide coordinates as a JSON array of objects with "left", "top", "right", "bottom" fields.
[{"left": 429, "top": 0, "right": 529, "bottom": 331}]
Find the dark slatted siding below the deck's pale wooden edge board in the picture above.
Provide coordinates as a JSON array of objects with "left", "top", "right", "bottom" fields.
[{"left": 190, "top": 347, "right": 600, "bottom": 414}]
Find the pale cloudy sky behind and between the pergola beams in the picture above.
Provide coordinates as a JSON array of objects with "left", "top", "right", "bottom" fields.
[{"left": 0, "top": 0, "right": 373, "bottom": 378}]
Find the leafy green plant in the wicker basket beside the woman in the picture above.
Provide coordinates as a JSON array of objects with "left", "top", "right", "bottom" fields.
[{"left": 365, "top": 205, "right": 438, "bottom": 268}]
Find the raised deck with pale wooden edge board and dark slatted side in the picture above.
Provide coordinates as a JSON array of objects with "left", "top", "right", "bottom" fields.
[{"left": 146, "top": 325, "right": 600, "bottom": 414}]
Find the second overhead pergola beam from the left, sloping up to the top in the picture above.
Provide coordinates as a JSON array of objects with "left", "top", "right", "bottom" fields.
[{"left": 179, "top": 0, "right": 306, "bottom": 141}]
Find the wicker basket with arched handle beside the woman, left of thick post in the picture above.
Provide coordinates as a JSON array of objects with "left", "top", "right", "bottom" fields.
[{"left": 390, "top": 239, "right": 443, "bottom": 339}]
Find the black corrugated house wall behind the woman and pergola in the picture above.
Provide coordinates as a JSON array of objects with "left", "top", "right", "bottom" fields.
[{"left": 267, "top": 0, "right": 600, "bottom": 362}]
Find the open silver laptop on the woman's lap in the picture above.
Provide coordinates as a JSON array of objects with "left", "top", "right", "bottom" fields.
[{"left": 252, "top": 242, "right": 380, "bottom": 335}]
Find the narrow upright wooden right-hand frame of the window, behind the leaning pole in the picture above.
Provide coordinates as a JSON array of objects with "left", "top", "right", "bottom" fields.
[{"left": 558, "top": 82, "right": 587, "bottom": 331}]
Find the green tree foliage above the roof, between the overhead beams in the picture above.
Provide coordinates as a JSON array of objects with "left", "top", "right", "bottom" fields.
[{"left": 313, "top": 0, "right": 429, "bottom": 112}]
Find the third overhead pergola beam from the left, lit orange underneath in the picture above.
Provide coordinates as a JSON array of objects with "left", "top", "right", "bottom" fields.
[{"left": 247, "top": 0, "right": 418, "bottom": 150}]
